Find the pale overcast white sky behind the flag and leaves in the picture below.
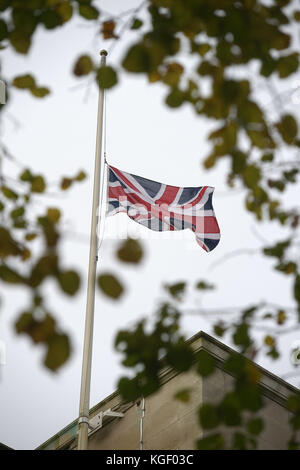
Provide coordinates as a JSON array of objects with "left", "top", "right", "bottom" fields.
[{"left": 0, "top": 0, "right": 300, "bottom": 449}]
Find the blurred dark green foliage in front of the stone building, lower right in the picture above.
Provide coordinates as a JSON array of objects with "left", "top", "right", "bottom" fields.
[{"left": 115, "top": 284, "right": 300, "bottom": 450}]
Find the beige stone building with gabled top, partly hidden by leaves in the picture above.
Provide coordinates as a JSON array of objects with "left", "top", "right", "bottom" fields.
[{"left": 38, "top": 332, "right": 299, "bottom": 450}]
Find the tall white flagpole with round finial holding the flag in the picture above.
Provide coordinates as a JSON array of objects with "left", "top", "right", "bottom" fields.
[{"left": 78, "top": 50, "right": 107, "bottom": 450}]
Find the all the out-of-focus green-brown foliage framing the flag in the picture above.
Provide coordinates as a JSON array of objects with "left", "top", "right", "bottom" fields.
[{"left": 0, "top": 0, "right": 300, "bottom": 449}]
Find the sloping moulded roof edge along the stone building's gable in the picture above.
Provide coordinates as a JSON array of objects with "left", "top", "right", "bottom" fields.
[{"left": 37, "top": 331, "right": 299, "bottom": 450}]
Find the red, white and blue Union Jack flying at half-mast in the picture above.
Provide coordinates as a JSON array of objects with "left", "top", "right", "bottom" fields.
[{"left": 108, "top": 166, "right": 220, "bottom": 251}]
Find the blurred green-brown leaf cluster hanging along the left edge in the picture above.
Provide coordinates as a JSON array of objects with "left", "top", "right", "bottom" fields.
[{"left": 0, "top": 146, "right": 85, "bottom": 371}]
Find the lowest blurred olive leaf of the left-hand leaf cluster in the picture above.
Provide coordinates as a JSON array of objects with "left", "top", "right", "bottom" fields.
[{"left": 44, "top": 333, "right": 71, "bottom": 371}]
